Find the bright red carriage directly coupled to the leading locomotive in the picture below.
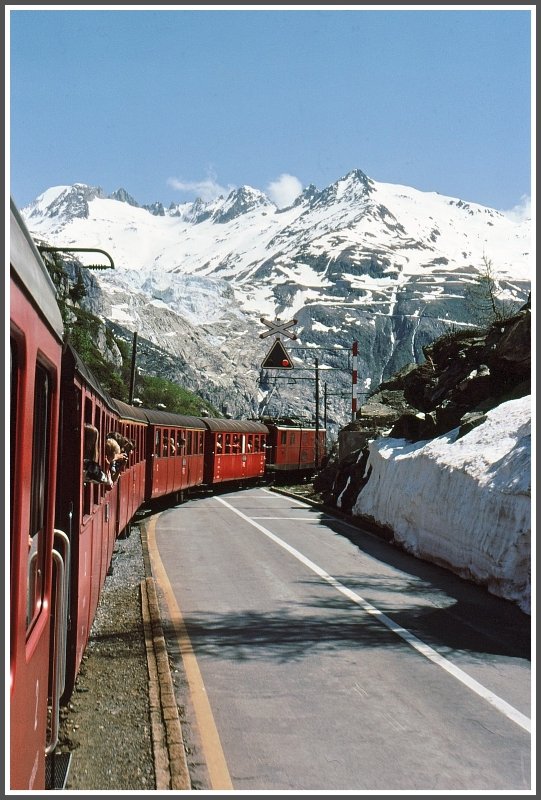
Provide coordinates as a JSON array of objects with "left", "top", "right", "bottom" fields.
[{"left": 202, "top": 417, "right": 268, "bottom": 486}]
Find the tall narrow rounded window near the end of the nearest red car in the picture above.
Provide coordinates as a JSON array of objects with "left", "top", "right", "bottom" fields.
[{"left": 26, "top": 364, "right": 51, "bottom": 629}]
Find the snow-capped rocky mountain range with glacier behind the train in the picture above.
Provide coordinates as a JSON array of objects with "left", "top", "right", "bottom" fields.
[{"left": 22, "top": 170, "right": 532, "bottom": 424}]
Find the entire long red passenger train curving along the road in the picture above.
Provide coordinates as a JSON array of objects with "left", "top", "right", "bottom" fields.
[{"left": 8, "top": 197, "right": 325, "bottom": 791}]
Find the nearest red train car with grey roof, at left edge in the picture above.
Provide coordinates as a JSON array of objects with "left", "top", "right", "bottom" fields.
[{"left": 9, "top": 202, "right": 67, "bottom": 790}]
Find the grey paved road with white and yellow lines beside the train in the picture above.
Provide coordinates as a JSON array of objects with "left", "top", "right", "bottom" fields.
[{"left": 149, "top": 488, "right": 531, "bottom": 792}]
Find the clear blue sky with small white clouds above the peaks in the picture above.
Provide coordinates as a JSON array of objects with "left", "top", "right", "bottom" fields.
[{"left": 6, "top": 4, "right": 535, "bottom": 216}]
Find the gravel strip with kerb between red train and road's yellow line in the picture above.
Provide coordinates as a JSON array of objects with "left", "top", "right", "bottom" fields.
[{"left": 58, "top": 525, "right": 169, "bottom": 791}]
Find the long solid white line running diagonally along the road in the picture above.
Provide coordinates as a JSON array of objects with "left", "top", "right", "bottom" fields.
[{"left": 213, "top": 496, "right": 532, "bottom": 733}]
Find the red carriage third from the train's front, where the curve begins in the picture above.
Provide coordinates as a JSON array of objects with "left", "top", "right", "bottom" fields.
[{"left": 143, "top": 409, "right": 206, "bottom": 501}]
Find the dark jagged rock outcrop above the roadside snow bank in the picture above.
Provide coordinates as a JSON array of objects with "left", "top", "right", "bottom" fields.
[{"left": 314, "top": 300, "right": 532, "bottom": 513}]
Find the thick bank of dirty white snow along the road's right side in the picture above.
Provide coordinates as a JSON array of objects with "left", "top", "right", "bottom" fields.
[{"left": 352, "top": 396, "right": 531, "bottom": 614}]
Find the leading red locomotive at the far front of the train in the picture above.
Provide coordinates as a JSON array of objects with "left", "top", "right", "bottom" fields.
[{"left": 263, "top": 417, "right": 326, "bottom": 478}]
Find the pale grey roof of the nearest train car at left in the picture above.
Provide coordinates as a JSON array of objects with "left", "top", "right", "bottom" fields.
[{"left": 9, "top": 198, "right": 64, "bottom": 341}]
